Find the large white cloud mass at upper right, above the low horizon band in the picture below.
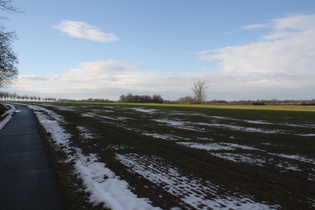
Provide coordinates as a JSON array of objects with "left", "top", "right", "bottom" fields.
[{"left": 198, "top": 15, "right": 315, "bottom": 83}]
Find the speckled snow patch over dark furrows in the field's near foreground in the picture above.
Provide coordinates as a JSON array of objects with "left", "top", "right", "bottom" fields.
[{"left": 116, "top": 153, "right": 276, "bottom": 209}]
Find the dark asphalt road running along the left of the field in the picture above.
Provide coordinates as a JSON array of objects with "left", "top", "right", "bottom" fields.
[{"left": 0, "top": 105, "right": 66, "bottom": 210}]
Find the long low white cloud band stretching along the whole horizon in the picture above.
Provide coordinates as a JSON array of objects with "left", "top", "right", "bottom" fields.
[{"left": 15, "top": 57, "right": 315, "bottom": 100}]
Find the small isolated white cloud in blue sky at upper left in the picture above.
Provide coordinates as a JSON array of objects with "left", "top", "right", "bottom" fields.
[{"left": 52, "top": 20, "right": 120, "bottom": 42}]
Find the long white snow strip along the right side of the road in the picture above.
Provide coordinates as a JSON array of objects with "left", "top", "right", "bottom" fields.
[{"left": 28, "top": 105, "right": 158, "bottom": 209}]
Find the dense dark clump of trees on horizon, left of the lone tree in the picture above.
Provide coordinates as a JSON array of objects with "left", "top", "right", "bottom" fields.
[{"left": 119, "top": 93, "right": 164, "bottom": 103}]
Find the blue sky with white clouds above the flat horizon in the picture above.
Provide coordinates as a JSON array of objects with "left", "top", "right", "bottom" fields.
[{"left": 1, "top": 0, "right": 315, "bottom": 101}]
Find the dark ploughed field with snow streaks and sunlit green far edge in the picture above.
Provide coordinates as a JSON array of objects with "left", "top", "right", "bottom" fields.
[{"left": 26, "top": 103, "right": 315, "bottom": 209}]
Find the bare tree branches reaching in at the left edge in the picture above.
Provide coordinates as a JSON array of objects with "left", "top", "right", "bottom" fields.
[{"left": 0, "top": 0, "right": 18, "bottom": 87}]
